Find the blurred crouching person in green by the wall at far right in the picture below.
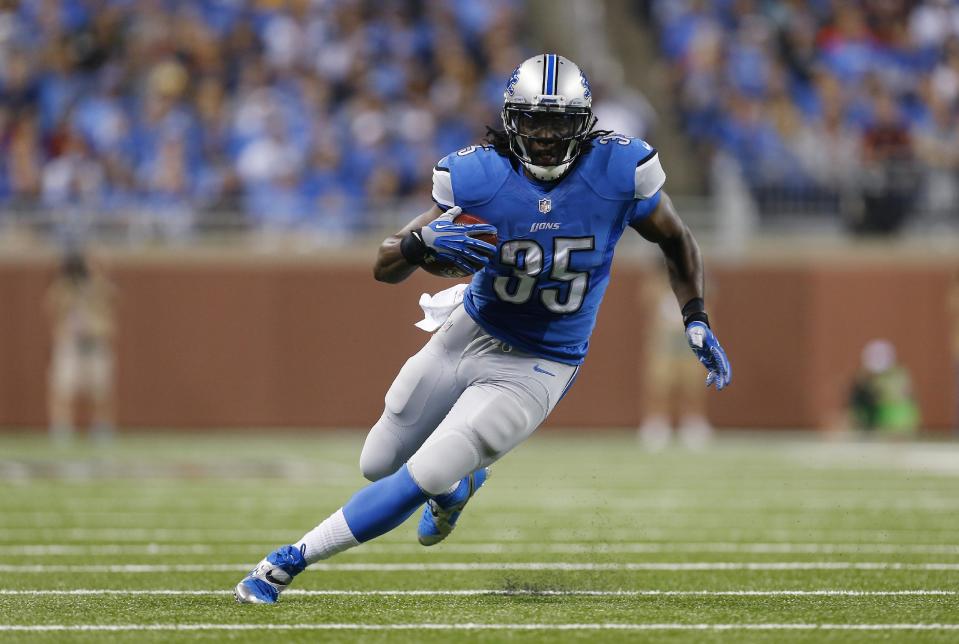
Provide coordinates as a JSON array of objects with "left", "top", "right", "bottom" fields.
[{"left": 849, "top": 339, "right": 919, "bottom": 436}]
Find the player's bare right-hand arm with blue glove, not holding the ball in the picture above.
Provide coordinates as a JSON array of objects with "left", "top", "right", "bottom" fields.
[{"left": 630, "top": 192, "right": 732, "bottom": 389}]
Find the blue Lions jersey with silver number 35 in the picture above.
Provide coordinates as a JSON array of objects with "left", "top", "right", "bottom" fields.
[{"left": 433, "top": 134, "right": 666, "bottom": 364}]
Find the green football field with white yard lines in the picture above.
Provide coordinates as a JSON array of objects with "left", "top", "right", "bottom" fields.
[{"left": 0, "top": 433, "right": 959, "bottom": 643}]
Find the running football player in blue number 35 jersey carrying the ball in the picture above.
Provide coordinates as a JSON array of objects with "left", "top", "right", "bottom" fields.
[{"left": 234, "top": 54, "right": 731, "bottom": 604}]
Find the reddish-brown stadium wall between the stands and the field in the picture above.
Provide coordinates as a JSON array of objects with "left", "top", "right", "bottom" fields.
[{"left": 0, "top": 256, "right": 956, "bottom": 430}]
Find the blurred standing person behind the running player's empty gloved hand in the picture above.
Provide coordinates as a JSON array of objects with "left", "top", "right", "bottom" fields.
[{"left": 639, "top": 273, "right": 713, "bottom": 451}]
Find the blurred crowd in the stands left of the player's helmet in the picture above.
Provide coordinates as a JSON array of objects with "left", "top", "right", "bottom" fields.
[{"left": 0, "top": 0, "right": 527, "bottom": 240}]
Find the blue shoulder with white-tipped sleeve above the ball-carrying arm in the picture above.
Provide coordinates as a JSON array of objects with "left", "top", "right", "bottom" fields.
[{"left": 433, "top": 145, "right": 511, "bottom": 208}]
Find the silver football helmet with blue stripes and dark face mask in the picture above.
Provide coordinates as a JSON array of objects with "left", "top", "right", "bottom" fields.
[{"left": 503, "top": 54, "right": 596, "bottom": 181}]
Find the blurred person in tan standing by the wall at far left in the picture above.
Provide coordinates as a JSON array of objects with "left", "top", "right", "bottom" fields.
[{"left": 46, "top": 252, "right": 114, "bottom": 442}]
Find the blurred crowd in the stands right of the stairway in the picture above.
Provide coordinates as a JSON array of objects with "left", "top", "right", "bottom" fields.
[{"left": 645, "top": 0, "right": 959, "bottom": 233}]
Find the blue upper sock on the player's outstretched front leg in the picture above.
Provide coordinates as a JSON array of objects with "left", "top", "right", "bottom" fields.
[{"left": 343, "top": 465, "right": 428, "bottom": 543}]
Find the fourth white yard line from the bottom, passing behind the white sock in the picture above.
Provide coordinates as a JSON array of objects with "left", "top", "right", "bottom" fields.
[{"left": 0, "top": 541, "right": 959, "bottom": 556}]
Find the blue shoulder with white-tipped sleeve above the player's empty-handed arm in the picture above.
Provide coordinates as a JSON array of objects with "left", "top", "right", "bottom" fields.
[{"left": 586, "top": 134, "right": 666, "bottom": 201}]
